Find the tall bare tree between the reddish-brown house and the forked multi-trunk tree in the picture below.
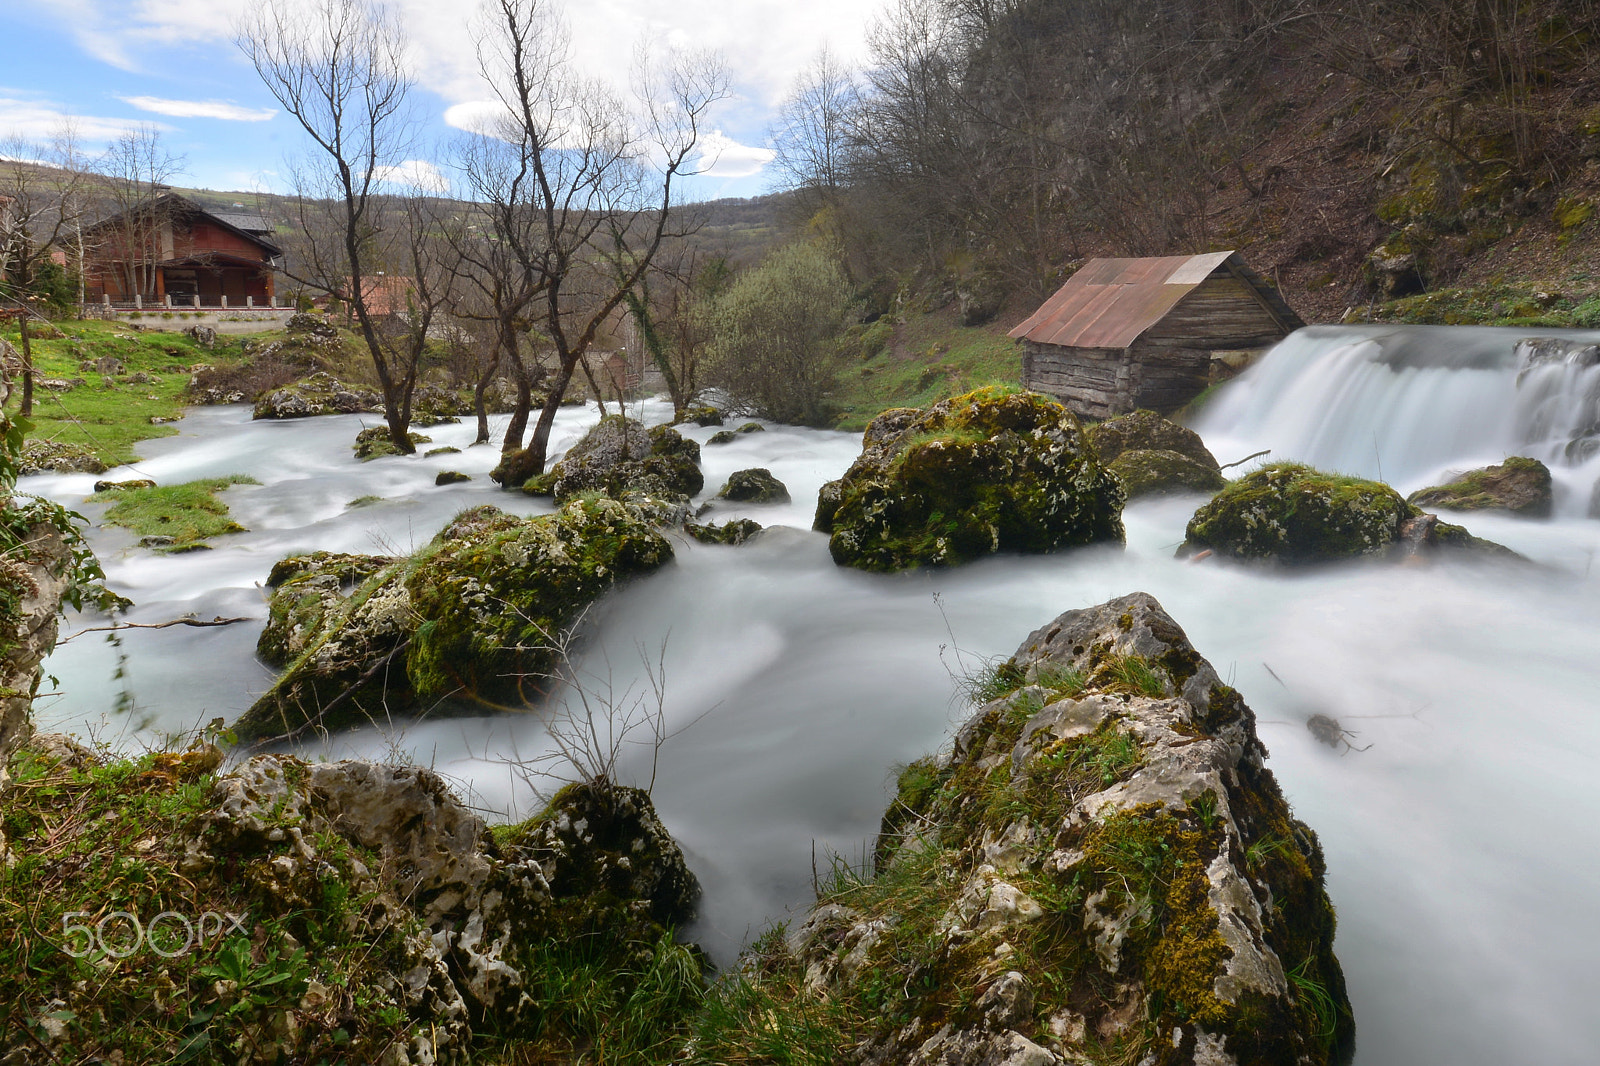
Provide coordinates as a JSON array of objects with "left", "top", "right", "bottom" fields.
[{"left": 238, "top": 0, "right": 435, "bottom": 453}]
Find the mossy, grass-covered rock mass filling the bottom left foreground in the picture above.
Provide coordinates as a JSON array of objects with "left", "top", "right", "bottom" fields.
[{"left": 0, "top": 738, "right": 704, "bottom": 1066}]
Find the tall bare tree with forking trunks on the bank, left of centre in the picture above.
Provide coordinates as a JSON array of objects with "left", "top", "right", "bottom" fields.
[{"left": 464, "top": 0, "right": 726, "bottom": 480}]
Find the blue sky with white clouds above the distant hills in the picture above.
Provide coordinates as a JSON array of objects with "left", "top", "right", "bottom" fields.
[{"left": 0, "top": 0, "right": 886, "bottom": 198}]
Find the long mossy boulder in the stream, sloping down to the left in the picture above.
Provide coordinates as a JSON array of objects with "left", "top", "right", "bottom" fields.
[{"left": 235, "top": 496, "right": 672, "bottom": 738}]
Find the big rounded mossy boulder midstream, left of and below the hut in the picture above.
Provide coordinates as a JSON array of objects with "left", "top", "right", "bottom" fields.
[{"left": 814, "top": 389, "right": 1123, "bottom": 571}]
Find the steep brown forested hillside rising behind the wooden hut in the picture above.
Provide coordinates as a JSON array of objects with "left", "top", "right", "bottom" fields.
[{"left": 778, "top": 0, "right": 1600, "bottom": 320}]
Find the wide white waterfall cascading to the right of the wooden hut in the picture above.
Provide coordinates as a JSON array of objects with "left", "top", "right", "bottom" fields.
[{"left": 1195, "top": 327, "right": 1600, "bottom": 517}]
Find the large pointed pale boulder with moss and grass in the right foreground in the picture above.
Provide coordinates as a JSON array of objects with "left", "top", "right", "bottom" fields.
[{"left": 699, "top": 592, "right": 1354, "bottom": 1066}]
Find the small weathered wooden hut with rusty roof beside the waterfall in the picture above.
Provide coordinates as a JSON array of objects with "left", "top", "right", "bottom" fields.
[{"left": 1011, "top": 251, "right": 1306, "bottom": 418}]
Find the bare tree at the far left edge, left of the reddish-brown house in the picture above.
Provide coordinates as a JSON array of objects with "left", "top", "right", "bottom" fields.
[{"left": 0, "top": 126, "right": 85, "bottom": 418}]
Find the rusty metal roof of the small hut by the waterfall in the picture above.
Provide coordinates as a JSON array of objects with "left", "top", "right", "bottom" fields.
[{"left": 1010, "top": 251, "right": 1304, "bottom": 347}]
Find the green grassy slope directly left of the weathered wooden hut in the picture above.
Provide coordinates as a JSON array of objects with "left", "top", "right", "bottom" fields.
[{"left": 830, "top": 311, "right": 1022, "bottom": 431}]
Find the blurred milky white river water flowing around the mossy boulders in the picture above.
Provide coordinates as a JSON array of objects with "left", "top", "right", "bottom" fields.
[{"left": 24, "top": 330, "right": 1600, "bottom": 1066}]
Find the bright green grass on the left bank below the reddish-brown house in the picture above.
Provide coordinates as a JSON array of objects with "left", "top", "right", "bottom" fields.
[{"left": 3, "top": 320, "right": 242, "bottom": 467}]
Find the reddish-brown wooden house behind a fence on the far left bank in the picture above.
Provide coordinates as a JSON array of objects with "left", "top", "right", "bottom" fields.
[{"left": 83, "top": 192, "right": 283, "bottom": 307}]
